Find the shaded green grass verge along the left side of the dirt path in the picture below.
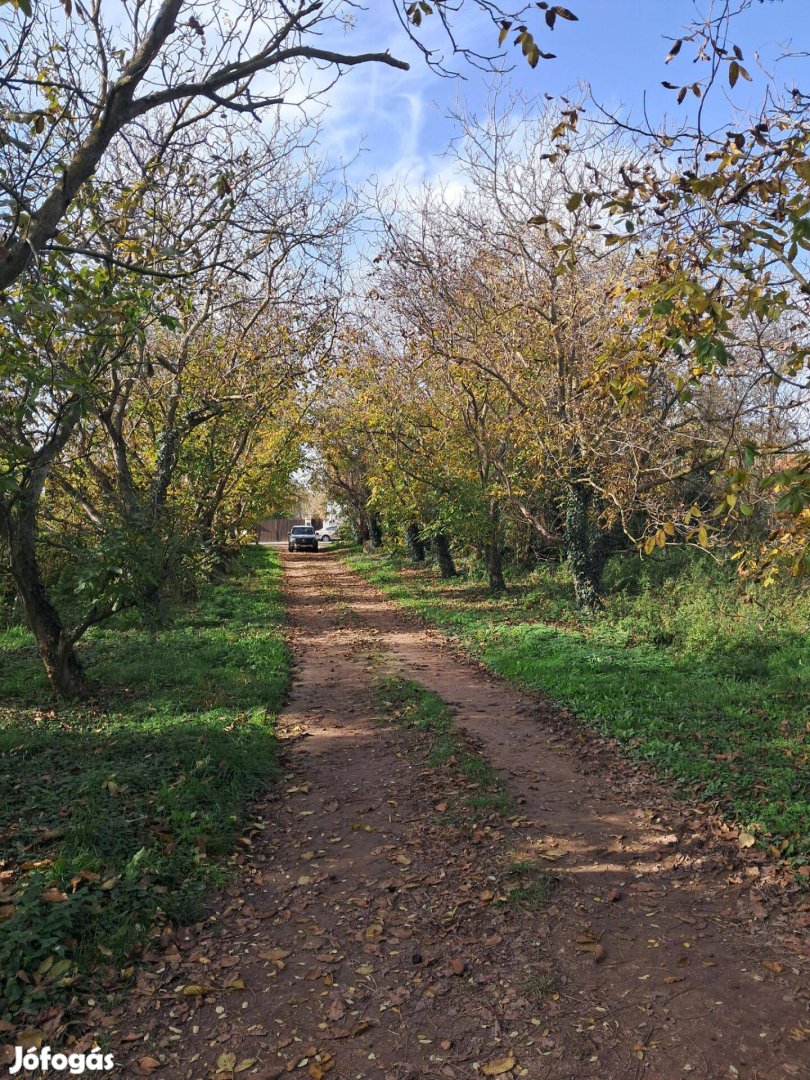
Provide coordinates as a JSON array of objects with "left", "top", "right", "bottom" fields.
[{"left": 0, "top": 550, "right": 291, "bottom": 1020}]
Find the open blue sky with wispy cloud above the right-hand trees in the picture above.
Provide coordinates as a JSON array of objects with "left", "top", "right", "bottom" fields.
[{"left": 306, "top": 0, "right": 810, "bottom": 184}]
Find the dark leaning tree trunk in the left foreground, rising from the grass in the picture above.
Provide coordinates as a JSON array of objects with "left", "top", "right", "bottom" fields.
[{"left": 4, "top": 507, "right": 89, "bottom": 701}]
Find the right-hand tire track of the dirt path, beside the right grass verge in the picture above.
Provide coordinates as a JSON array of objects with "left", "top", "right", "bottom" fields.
[{"left": 319, "top": 552, "right": 810, "bottom": 1078}]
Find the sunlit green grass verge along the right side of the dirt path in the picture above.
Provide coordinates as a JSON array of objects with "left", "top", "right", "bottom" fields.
[{"left": 346, "top": 552, "right": 810, "bottom": 866}]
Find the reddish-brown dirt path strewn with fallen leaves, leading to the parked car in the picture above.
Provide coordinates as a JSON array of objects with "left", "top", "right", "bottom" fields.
[{"left": 120, "top": 554, "right": 810, "bottom": 1080}]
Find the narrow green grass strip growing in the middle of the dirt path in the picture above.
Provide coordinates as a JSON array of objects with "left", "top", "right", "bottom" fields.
[{"left": 378, "top": 677, "right": 514, "bottom": 820}]
